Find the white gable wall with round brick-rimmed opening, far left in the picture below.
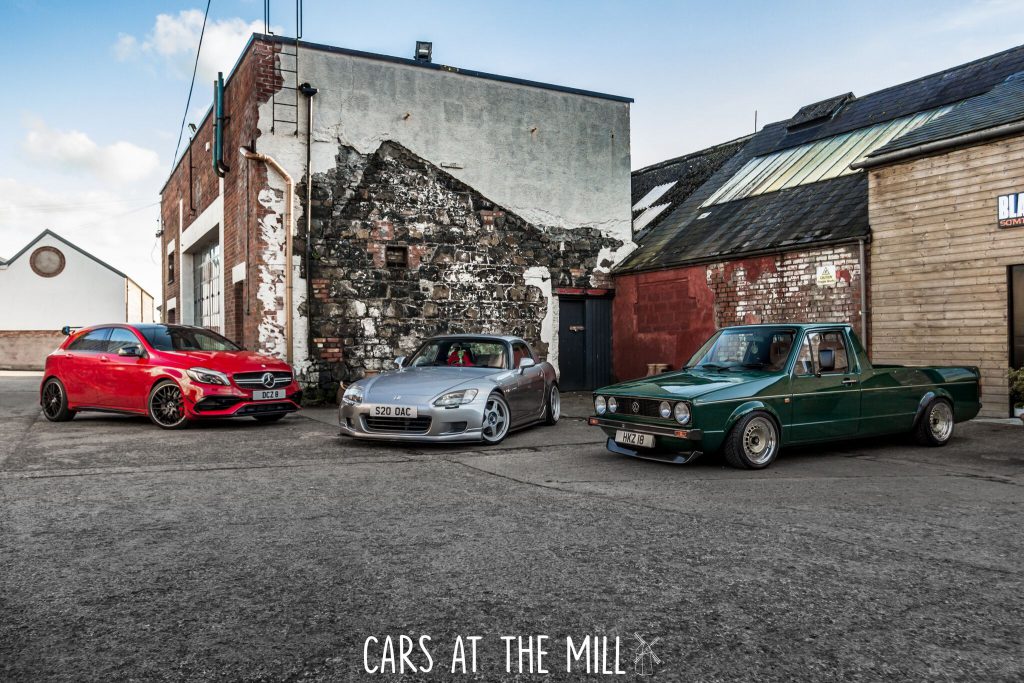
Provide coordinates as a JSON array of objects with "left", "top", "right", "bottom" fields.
[{"left": 0, "top": 234, "right": 133, "bottom": 330}]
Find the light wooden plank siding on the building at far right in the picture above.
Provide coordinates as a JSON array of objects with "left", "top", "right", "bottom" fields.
[{"left": 868, "top": 136, "right": 1024, "bottom": 418}]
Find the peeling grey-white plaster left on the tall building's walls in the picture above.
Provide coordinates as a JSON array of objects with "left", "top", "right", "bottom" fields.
[{"left": 258, "top": 42, "right": 635, "bottom": 385}]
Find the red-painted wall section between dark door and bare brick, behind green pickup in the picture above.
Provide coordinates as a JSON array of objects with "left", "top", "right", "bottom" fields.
[{"left": 611, "top": 265, "right": 716, "bottom": 381}]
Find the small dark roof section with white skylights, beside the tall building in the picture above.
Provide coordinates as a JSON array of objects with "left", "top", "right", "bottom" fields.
[{"left": 632, "top": 135, "right": 751, "bottom": 241}]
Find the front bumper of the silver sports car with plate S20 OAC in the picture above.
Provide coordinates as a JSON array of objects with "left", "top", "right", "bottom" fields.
[{"left": 338, "top": 400, "right": 483, "bottom": 442}]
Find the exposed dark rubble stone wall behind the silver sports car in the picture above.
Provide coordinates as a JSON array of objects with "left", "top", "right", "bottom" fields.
[{"left": 296, "top": 142, "right": 622, "bottom": 385}]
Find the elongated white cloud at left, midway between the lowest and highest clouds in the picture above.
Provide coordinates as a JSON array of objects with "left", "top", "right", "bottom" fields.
[{"left": 22, "top": 119, "right": 160, "bottom": 183}]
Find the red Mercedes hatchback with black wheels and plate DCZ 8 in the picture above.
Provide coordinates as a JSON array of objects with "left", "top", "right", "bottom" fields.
[{"left": 39, "top": 325, "right": 302, "bottom": 429}]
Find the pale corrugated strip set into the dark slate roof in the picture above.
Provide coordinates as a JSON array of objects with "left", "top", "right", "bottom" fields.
[{"left": 702, "top": 106, "right": 950, "bottom": 207}]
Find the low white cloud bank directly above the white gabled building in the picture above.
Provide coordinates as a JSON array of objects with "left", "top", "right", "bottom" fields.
[{"left": 0, "top": 177, "right": 160, "bottom": 299}]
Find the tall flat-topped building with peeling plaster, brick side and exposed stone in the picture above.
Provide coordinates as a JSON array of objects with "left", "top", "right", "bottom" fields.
[{"left": 161, "top": 35, "right": 634, "bottom": 392}]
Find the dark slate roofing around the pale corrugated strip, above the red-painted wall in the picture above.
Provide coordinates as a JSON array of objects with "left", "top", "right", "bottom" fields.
[{"left": 614, "top": 46, "right": 1024, "bottom": 274}]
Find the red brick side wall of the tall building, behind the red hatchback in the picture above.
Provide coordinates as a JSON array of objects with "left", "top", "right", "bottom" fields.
[{"left": 161, "top": 36, "right": 280, "bottom": 348}]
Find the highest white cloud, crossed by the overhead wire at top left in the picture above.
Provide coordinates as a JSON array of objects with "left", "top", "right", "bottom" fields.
[{"left": 114, "top": 9, "right": 263, "bottom": 84}]
